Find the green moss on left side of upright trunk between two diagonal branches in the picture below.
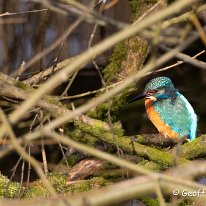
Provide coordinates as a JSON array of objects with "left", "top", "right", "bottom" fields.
[{"left": 103, "top": 41, "right": 127, "bottom": 84}]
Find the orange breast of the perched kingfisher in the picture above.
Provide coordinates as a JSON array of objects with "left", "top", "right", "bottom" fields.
[{"left": 145, "top": 99, "right": 179, "bottom": 138}]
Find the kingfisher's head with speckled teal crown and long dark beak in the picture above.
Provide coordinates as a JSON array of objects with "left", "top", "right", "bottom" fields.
[{"left": 129, "top": 77, "right": 177, "bottom": 102}]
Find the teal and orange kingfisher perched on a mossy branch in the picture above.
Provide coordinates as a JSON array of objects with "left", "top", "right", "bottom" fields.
[{"left": 129, "top": 77, "right": 197, "bottom": 141}]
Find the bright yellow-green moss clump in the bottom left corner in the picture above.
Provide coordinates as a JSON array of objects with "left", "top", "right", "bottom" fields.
[{"left": 0, "top": 174, "right": 20, "bottom": 198}]
